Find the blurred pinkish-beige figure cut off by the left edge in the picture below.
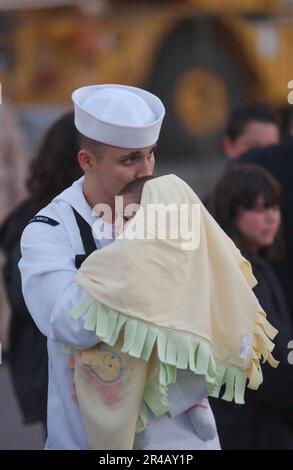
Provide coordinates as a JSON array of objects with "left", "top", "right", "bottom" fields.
[{"left": 0, "top": 103, "right": 28, "bottom": 351}]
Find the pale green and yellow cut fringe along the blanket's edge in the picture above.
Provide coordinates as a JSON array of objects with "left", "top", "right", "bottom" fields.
[{"left": 71, "top": 294, "right": 278, "bottom": 430}]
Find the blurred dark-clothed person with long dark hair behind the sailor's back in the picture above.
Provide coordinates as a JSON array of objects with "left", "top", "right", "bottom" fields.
[{"left": 0, "top": 112, "right": 81, "bottom": 430}]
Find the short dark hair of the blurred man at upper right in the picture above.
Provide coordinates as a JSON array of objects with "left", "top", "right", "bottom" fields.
[{"left": 225, "top": 103, "right": 280, "bottom": 141}]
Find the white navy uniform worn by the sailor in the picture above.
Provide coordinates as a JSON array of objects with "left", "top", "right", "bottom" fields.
[{"left": 19, "top": 178, "right": 220, "bottom": 449}]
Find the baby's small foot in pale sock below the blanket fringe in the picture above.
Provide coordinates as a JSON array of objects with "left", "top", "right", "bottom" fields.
[{"left": 187, "top": 398, "right": 217, "bottom": 441}]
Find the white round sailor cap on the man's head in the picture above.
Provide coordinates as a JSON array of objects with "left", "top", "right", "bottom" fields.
[{"left": 72, "top": 85, "right": 165, "bottom": 149}]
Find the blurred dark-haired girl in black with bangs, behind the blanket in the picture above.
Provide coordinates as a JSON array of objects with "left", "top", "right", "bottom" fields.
[{"left": 210, "top": 164, "right": 293, "bottom": 450}]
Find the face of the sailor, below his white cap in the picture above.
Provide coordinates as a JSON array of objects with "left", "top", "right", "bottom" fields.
[{"left": 91, "top": 144, "right": 157, "bottom": 204}]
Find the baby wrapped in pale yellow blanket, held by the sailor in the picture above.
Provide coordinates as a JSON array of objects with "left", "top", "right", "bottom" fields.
[{"left": 71, "top": 175, "right": 277, "bottom": 449}]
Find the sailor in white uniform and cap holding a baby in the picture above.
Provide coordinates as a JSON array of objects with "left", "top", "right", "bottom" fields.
[{"left": 19, "top": 85, "right": 219, "bottom": 450}]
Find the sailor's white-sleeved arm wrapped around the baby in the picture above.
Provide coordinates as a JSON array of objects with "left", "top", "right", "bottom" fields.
[{"left": 19, "top": 217, "right": 98, "bottom": 349}]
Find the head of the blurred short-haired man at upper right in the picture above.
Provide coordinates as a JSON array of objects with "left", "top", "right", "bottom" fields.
[{"left": 223, "top": 103, "right": 280, "bottom": 160}]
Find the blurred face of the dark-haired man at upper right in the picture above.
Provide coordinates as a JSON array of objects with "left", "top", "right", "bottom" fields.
[{"left": 224, "top": 121, "right": 280, "bottom": 160}]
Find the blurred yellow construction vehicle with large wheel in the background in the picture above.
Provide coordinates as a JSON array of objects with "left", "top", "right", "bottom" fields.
[{"left": 0, "top": 0, "right": 293, "bottom": 158}]
